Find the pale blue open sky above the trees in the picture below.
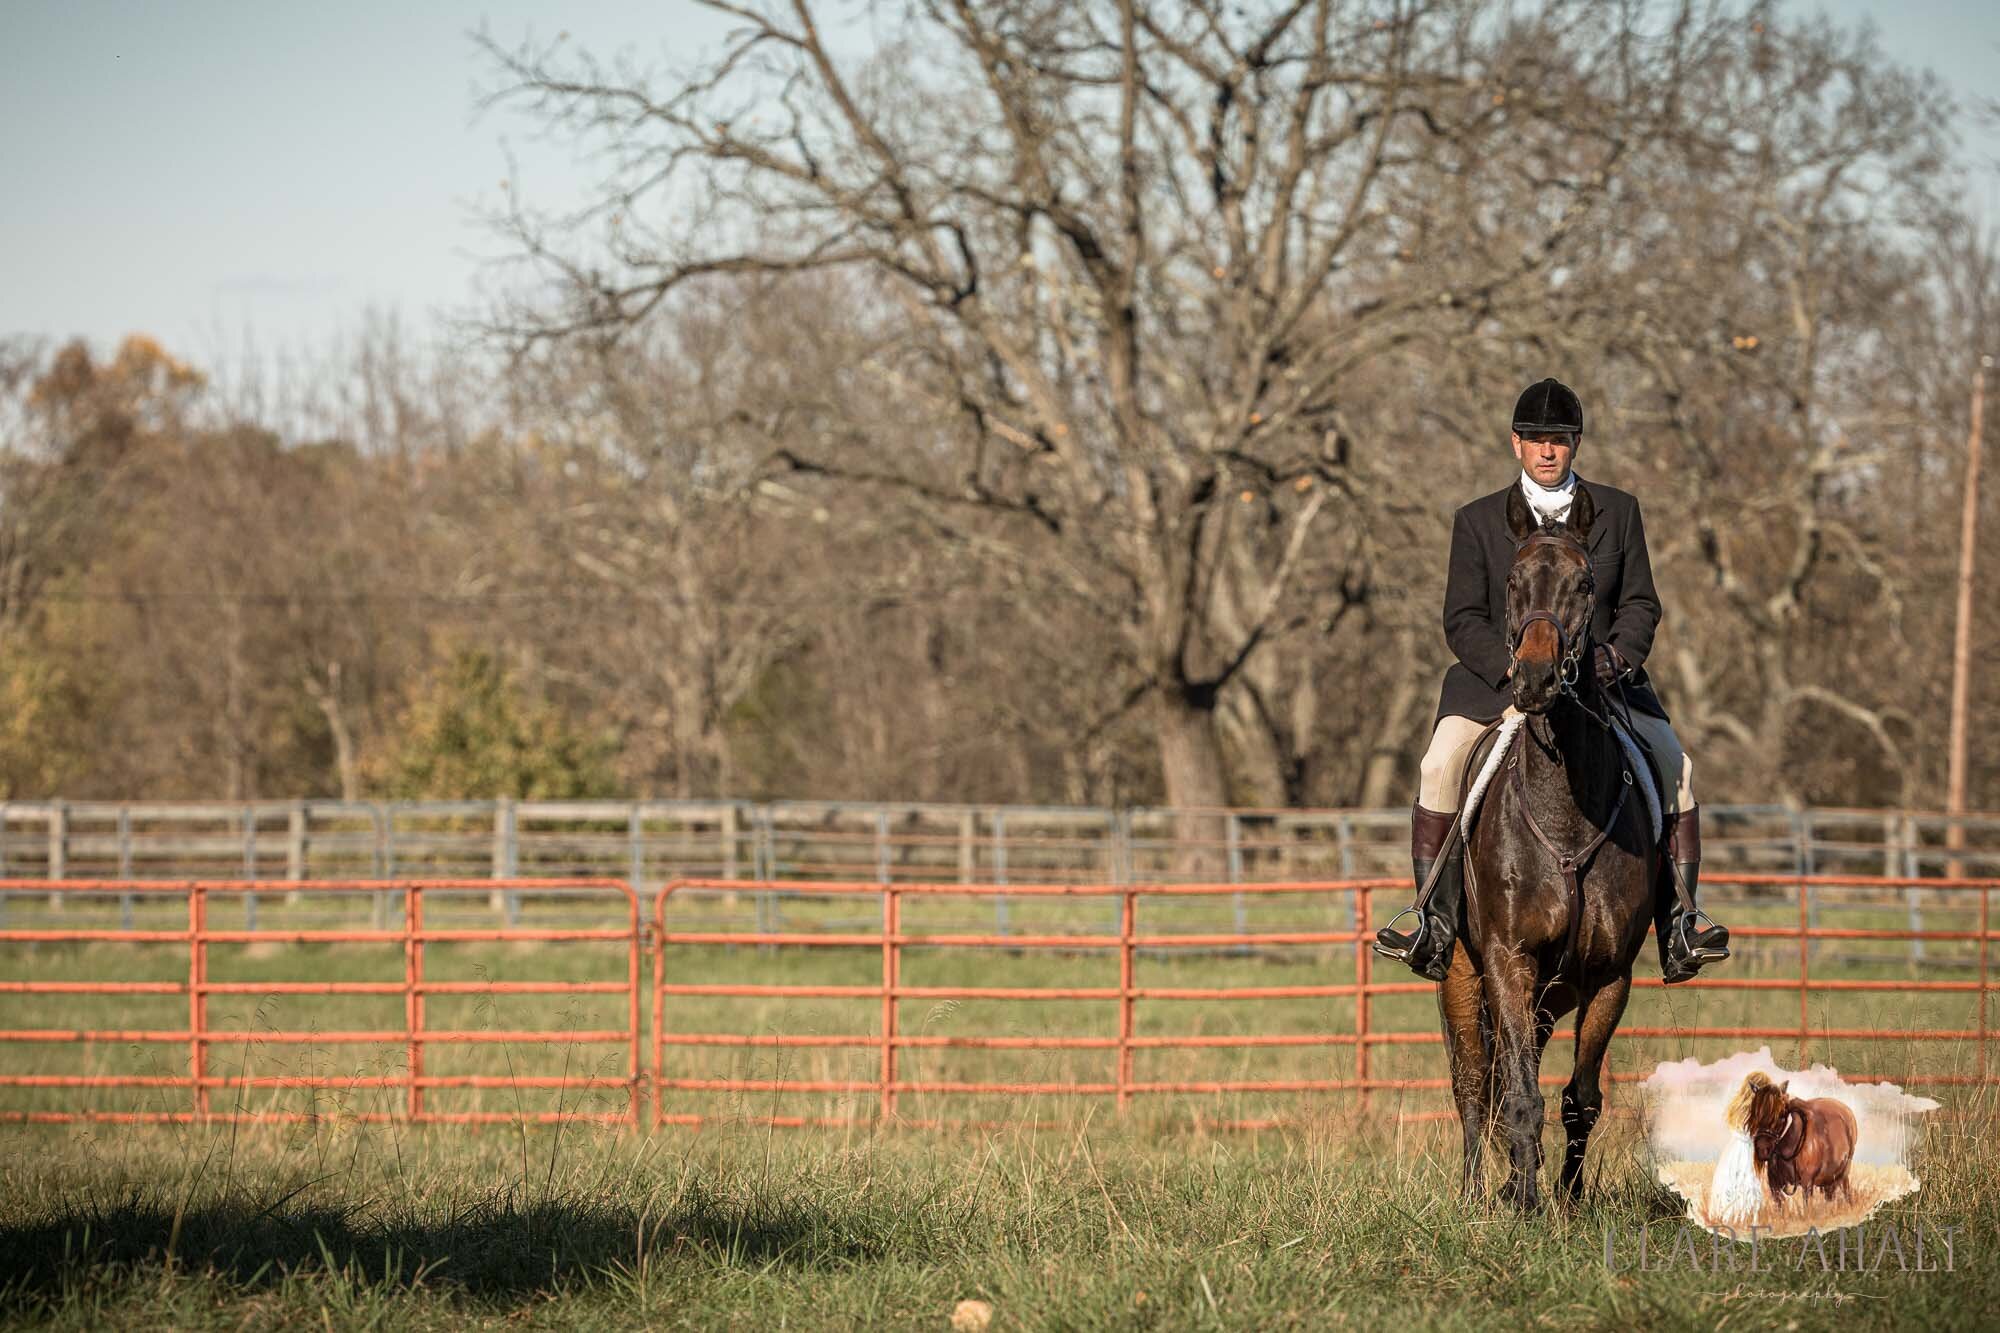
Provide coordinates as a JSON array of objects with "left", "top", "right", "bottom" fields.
[{"left": 0, "top": 0, "right": 2000, "bottom": 378}]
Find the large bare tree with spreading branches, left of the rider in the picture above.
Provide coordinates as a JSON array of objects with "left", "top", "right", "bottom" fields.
[{"left": 464, "top": 0, "right": 1736, "bottom": 852}]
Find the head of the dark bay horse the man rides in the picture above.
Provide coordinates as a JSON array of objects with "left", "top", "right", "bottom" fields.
[{"left": 1506, "top": 486, "right": 1598, "bottom": 713}]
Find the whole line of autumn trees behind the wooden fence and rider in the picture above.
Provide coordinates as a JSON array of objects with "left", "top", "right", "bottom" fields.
[{"left": 0, "top": 0, "right": 2000, "bottom": 809}]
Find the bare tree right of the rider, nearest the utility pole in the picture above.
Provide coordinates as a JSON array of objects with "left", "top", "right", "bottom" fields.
[{"left": 1566, "top": 10, "right": 1950, "bottom": 805}]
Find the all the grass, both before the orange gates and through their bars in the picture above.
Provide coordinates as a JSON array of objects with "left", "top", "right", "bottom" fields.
[{"left": 0, "top": 876, "right": 2000, "bottom": 1329}]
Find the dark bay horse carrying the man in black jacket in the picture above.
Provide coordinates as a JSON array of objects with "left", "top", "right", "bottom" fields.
[{"left": 1438, "top": 486, "right": 1666, "bottom": 1211}]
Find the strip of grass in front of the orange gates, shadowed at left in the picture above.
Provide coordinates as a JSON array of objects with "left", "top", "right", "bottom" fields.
[{"left": 0, "top": 1096, "right": 2000, "bottom": 1329}]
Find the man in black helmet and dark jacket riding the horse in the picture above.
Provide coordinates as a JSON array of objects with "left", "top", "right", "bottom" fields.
[{"left": 1376, "top": 378, "right": 1730, "bottom": 985}]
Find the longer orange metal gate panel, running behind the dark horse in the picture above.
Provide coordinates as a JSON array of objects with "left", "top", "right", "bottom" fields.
[{"left": 652, "top": 875, "right": 2000, "bottom": 1123}]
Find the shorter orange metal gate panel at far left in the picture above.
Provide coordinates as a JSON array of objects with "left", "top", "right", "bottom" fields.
[{"left": 0, "top": 879, "right": 644, "bottom": 1125}]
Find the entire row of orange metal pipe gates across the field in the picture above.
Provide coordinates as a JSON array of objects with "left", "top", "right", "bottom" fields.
[{"left": 0, "top": 875, "right": 2000, "bottom": 1125}]
